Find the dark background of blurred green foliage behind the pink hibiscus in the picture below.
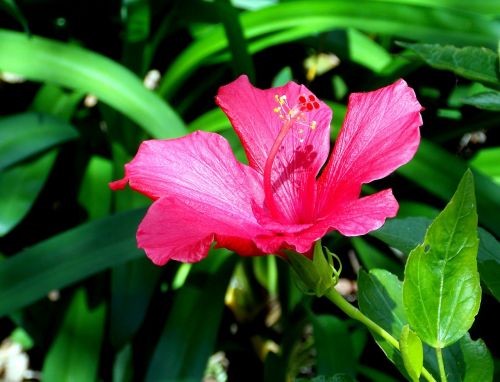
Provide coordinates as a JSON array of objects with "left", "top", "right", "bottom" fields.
[{"left": 0, "top": 0, "right": 500, "bottom": 382}]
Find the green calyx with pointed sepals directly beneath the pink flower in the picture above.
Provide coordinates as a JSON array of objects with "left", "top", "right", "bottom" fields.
[{"left": 286, "top": 240, "right": 342, "bottom": 297}]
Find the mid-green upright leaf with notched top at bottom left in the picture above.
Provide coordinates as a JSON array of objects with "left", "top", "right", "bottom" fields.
[{"left": 42, "top": 289, "right": 106, "bottom": 382}]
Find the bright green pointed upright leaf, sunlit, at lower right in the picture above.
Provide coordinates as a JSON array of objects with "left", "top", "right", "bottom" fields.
[{"left": 403, "top": 171, "right": 481, "bottom": 348}]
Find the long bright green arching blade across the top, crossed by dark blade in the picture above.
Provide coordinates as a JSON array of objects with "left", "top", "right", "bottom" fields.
[{"left": 158, "top": 0, "right": 500, "bottom": 97}]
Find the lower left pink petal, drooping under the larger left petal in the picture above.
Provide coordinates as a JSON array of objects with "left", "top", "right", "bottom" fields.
[{"left": 137, "top": 197, "right": 262, "bottom": 265}]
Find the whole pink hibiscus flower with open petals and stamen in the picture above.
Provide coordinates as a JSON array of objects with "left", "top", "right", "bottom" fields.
[{"left": 110, "top": 76, "right": 422, "bottom": 265}]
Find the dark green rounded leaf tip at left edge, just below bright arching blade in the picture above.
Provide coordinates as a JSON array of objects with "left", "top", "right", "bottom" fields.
[{"left": 0, "top": 113, "right": 78, "bottom": 171}]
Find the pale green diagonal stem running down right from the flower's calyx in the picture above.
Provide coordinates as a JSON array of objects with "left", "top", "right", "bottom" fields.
[{"left": 325, "top": 288, "right": 438, "bottom": 382}]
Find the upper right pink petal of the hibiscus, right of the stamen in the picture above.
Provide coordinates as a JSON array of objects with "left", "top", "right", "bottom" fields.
[{"left": 317, "top": 80, "right": 422, "bottom": 216}]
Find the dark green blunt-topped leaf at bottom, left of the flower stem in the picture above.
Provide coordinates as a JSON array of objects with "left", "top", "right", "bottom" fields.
[{"left": 311, "top": 315, "right": 356, "bottom": 377}]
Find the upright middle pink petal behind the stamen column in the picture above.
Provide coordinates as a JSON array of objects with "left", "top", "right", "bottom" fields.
[{"left": 216, "top": 76, "right": 332, "bottom": 223}]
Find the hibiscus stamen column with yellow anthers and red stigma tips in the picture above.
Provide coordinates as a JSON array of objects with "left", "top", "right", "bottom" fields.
[{"left": 264, "top": 94, "right": 320, "bottom": 220}]
